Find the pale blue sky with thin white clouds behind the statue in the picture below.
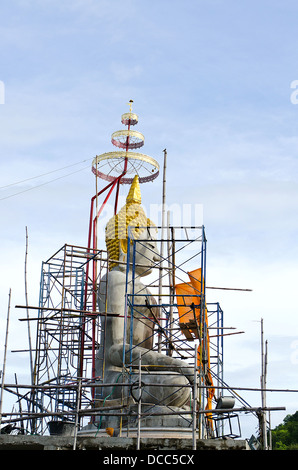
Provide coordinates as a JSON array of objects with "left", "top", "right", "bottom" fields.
[{"left": 0, "top": 0, "right": 298, "bottom": 437}]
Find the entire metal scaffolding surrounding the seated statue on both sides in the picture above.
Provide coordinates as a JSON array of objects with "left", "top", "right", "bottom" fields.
[{"left": 2, "top": 226, "right": 242, "bottom": 445}]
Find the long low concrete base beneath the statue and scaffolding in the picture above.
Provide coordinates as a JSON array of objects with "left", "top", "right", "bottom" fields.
[{"left": 0, "top": 434, "right": 249, "bottom": 452}]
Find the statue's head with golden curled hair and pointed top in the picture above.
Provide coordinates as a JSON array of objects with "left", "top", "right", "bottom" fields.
[{"left": 106, "top": 176, "right": 159, "bottom": 275}]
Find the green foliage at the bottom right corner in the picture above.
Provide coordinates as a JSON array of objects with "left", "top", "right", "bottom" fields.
[{"left": 272, "top": 411, "right": 298, "bottom": 450}]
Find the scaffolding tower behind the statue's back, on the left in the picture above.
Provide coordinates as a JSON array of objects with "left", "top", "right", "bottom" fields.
[{"left": 17, "top": 244, "right": 107, "bottom": 434}]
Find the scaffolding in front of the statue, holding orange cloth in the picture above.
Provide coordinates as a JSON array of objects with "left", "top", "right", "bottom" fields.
[{"left": 116, "top": 226, "right": 223, "bottom": 438}]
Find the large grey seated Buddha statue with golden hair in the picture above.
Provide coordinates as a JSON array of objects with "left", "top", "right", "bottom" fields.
[{"left": 97, "top": 176, "right": 194, "bottom": 430}]
